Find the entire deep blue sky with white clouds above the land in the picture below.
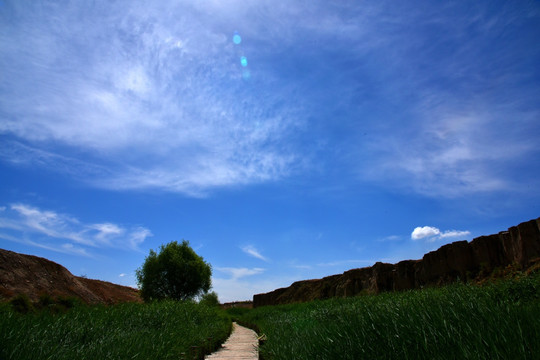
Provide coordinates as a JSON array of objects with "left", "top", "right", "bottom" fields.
[{"left": 0, "top": 0, "right": 540, "bottom": 301}]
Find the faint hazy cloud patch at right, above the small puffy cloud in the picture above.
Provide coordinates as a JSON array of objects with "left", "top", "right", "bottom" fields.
[{"left": 366, "top": 105, "right": 538, "bottom": 197}]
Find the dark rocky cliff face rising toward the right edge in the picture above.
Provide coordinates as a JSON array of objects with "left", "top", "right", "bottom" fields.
[{"left": 253, "top": 218, "right": 540, "bottom": 307}]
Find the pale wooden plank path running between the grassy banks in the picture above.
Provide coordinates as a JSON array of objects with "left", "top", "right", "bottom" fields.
[{"left": 205, "top": 322, "right": 259, "bottom": 360}]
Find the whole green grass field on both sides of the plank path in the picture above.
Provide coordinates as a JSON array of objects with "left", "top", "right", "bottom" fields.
[{"left": 0, "top": 273, "right": 540, "bottom": 360}]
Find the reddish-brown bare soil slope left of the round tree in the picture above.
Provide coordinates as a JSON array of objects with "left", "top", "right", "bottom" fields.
[{"left": 0, "top": 249, "right": 141, "bottom": 304}]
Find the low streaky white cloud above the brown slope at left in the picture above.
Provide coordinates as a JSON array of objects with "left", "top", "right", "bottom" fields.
[{"left": 0, "top": 204, "right": 152, "bottom": 256}]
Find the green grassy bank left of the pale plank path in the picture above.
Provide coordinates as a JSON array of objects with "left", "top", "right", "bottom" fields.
[{"left": 0, "top": 301, "right": 231, "bottom": 360}]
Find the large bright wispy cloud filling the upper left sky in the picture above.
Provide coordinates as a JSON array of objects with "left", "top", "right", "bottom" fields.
[{"left": 0, "top": 1, "right": 302, "bottom": 196}]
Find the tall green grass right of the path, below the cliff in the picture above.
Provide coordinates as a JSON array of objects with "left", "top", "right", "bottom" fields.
[{"left": 240, "top": 274, "right": 540, "bottom": 360}]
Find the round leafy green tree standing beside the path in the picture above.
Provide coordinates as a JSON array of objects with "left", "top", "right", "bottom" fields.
[{"left": 136, "top": 240, "right": 212, "bottom": 301}]
